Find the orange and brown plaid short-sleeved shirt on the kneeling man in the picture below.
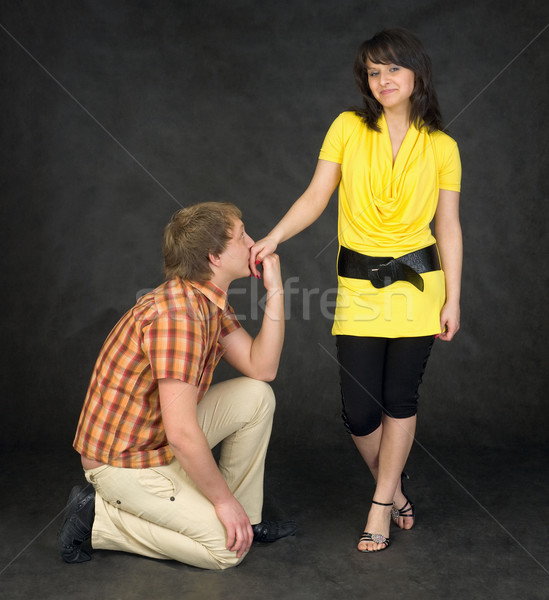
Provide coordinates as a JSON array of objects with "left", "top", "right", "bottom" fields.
[{"left": 73, "top": 279, "right": 240, "bottom": 468}]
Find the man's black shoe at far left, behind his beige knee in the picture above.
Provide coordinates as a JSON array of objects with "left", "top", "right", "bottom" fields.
[{"left": 57, "top": 485, "right": 95, "bottom": 563}]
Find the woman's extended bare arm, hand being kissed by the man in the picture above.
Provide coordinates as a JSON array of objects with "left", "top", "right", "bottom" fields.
[{"left": 250, "top": 160, "right": 341, "bottom": 275}]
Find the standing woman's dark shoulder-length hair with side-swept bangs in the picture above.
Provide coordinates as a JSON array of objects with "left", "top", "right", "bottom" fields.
[{"left": 354, "top": 29, "right": 444, "bottom": 133}]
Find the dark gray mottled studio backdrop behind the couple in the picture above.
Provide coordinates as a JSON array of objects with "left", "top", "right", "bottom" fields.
[{"left": 0, "top": 0, "right": 549, "bottom": 448}]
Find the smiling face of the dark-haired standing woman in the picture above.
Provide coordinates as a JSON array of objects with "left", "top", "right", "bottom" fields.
[{"left": 366, "top": 60, "right": 415, "bottom": 110}]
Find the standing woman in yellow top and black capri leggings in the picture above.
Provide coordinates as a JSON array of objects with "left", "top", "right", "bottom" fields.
[{"left": 250, "top": 29, "right": 462, "bottom": 552}]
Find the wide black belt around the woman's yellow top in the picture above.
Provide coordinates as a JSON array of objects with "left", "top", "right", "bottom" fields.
[{"left": 337, "top": 244, "right": 440, "bottom": 292}]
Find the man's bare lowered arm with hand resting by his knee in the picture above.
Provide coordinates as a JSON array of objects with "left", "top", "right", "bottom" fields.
[{"left": 158, "top": 379, "right": 253, "bottom": 558}]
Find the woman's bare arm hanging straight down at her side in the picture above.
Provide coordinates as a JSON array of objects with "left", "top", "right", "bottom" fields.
[{"left": 435, "top": 190, "right": 463, "bottom": 342}]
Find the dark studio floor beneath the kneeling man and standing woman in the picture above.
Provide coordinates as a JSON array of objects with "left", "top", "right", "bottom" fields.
[{"left": 0, "top": 444, "right": 549, "bottom": 600}]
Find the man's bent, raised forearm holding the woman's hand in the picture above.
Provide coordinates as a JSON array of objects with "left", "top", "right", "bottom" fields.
[{"left": 221, "top": 254, "right": 284, "bottom": 381}]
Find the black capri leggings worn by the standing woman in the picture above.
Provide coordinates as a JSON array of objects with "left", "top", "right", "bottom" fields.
[{"left": 337, "top": 335, "right": 435, "bottom": 436}]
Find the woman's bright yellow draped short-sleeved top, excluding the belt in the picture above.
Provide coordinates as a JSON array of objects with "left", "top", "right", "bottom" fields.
[{"left": 320, "top": 112, "right": 461, "bottom": 337}]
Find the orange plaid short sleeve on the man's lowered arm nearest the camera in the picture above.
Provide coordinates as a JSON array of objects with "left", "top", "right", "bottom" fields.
[{"left": 142, "top": 312, "right": 206, "bottom": 386}]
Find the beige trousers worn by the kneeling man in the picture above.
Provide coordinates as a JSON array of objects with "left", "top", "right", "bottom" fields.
[{"left": 85, "top": 377, "right": 275, "bottom": 569}]
